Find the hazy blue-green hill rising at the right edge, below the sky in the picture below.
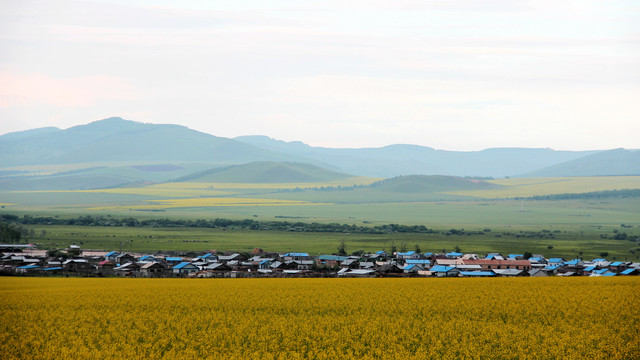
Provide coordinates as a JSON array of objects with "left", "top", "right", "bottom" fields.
[{"left": 522, "top": 149, "right": 640, "bottom": 177}]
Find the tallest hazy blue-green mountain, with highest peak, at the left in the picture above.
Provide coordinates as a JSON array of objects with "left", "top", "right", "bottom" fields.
[{"left": 0, "top": 118, "right": 312, "bottom": 167}]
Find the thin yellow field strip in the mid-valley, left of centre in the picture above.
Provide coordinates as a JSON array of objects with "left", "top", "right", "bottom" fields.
[{"left": 91, "top": 197, "right": 322, "bottom": 210}]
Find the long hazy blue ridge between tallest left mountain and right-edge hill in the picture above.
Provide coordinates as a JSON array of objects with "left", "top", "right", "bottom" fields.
[{"left": 235, "top": 136, "right": 597, "bottom": 177}]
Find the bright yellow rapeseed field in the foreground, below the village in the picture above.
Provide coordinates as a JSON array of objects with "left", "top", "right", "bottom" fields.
[{"left": 0, "top": 277, "right": 640, "bottom": 360}]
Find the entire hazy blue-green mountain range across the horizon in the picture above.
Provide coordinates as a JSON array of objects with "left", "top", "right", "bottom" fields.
[{"left": 0, "top": 117, "right": 640, "bottom": 188}]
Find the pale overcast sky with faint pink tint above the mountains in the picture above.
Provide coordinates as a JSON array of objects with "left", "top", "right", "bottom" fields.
[{"left": 0, "top": 0, "right": 640, "bottom": 151}]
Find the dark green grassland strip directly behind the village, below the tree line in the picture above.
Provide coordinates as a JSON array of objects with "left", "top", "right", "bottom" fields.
[{"left": 21, "top": 225, "right": 640, "bottom": 259}]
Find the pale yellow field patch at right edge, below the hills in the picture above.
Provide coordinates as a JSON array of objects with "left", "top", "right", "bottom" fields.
[{"left": 445, "top": 176, "right": 640, "bottom": 198}]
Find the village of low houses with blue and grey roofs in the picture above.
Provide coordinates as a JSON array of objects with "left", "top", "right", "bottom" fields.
[{"left": 0, "top": 245, "right": 640, "bottom": 278}]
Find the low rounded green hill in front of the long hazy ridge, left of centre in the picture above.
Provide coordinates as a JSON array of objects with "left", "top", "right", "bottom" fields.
[{"left": 176, "top": 161, "right": 351, "bottom": 183}]
